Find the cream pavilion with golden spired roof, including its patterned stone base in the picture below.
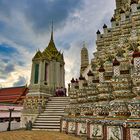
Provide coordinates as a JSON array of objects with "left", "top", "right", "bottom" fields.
[{"left": 21, "top": 26, "right": 65, "bottom": 128}]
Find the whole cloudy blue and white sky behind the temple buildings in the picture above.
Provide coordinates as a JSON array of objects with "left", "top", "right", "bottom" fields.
[{"left": 0, "top": 0, "right": 115, "bottom": 87}]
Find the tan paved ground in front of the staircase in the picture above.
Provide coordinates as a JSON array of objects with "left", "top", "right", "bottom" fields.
[{"left": 0, "top": 131, "right": 81, "bottom": 140}]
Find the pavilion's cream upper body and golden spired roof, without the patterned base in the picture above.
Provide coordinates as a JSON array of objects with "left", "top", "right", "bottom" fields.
[{"left": 29, "top": 25, "right": 65, "bottom": 94}]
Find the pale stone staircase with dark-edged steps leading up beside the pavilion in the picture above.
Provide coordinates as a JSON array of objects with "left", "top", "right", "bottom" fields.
[{"left": 33, "top": 97, "right": 70, "bottom": 131}]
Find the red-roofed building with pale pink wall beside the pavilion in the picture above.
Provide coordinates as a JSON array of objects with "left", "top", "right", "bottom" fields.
[{"left": 0, "top": 86, "right": 28, "bottom": 126}]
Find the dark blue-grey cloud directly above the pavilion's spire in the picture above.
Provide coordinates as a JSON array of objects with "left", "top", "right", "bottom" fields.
[{"left": 25, "top": 0, "right": 82, "bottom": 33}]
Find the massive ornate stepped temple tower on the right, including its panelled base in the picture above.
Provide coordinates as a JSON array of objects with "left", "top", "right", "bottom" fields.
[{"left": 61, "top": 0, "right": 140, "bottom": 140}]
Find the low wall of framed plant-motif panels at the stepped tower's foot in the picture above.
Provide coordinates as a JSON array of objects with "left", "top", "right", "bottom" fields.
[{"left": 60, "top": 117, "right": 140, "bottom": 140}]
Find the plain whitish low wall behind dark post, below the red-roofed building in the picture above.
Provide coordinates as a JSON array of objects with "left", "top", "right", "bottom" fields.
[{"left": 0, "top": 121, "right": 20, "bottom": 132}]
